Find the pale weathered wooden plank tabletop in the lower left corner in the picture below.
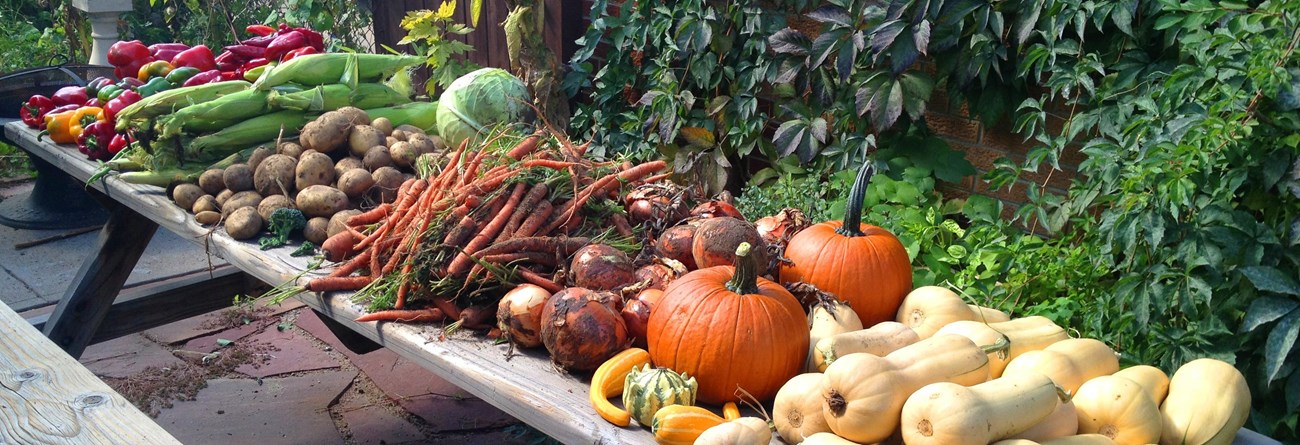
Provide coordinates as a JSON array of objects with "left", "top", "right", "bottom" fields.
[{"left": 0, "top": 303, "right": 181, "bottom": 445}]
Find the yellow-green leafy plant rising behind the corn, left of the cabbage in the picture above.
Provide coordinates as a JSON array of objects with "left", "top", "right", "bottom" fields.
[{"left": 398, "top": 0, "right": 482, "bottom": 98}]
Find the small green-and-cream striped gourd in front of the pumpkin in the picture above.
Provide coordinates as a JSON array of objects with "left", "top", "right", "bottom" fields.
[{"left": 623, "top": 364, "right": 698, "bottom": 425}]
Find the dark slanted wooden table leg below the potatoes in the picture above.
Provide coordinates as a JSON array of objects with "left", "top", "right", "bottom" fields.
[{"left": 44, "top": 191, "right": 159, "bottom": 358}]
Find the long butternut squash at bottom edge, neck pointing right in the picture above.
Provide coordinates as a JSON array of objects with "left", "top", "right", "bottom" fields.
[{"left": 901, "top": 373, "right": 1061, "bottom": 445}]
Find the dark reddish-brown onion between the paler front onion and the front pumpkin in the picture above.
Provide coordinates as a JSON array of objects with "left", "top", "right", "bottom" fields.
[{"left": 542, "top": 288, "right": 629, "bottom": 372}]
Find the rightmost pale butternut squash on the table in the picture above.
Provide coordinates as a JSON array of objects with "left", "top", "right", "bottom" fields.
[{"left": 1160, "top": 358, "right": 1251, "bottom": 445}]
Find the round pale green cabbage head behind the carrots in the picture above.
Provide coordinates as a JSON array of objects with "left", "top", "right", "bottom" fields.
[{"left": 438, "top": 68, "right": 532, "bottom": 147}]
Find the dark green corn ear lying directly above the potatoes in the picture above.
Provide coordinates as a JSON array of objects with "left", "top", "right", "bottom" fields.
[{"left": 186, "top": 109, "right": 320, "bottom": 159}]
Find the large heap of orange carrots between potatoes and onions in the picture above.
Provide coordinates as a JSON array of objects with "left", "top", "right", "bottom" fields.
[{"left": 303, "top": 131, "right": 667, "bottom": 321}]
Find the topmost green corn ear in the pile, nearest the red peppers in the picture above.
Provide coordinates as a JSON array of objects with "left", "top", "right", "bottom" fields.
[{"left": 254, "top": 53, "right": 424, "bottom": 90}]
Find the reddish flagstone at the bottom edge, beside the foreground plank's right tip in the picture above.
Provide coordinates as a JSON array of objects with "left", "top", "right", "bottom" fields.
[{"left": 157, "top": 371, "right": 356, "bottom": 445}]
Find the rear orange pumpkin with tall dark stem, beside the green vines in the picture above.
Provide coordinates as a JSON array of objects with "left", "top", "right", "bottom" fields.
[{"left": 780, "top": 161, "right": 911, "bottom": 327}]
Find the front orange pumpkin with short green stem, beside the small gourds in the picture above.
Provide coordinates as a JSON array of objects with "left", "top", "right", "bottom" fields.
[{"left": 647, "top": 243, "right": 809, "bottom": 405}]
